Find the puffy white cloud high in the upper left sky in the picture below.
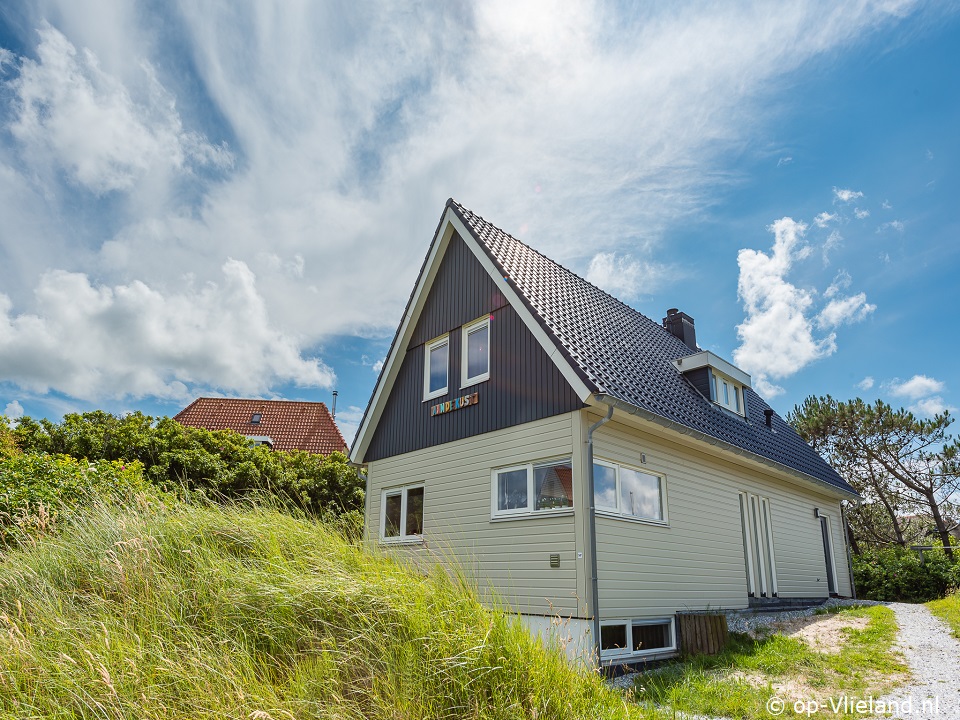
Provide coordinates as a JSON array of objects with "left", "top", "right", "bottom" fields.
[{"left": 10, "top": 23, "right": 230, "bottom": 193}]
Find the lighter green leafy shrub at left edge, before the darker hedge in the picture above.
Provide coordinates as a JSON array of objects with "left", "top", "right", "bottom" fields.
[{"left": 0, "top": 453, "right": 149, "bottom": 542}]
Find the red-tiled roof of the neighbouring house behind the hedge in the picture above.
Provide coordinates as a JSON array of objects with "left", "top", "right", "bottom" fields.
[{"left": 173, "top": 398, "right": 347, "bottom": 455}]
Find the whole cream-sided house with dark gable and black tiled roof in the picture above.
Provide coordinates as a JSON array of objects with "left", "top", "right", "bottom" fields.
[{"left": 351, "top": 200, "right": 858, "bottom": 663}]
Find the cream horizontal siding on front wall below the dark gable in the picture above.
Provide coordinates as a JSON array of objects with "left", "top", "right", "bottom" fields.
[{"left": 367, "top": 414, "right": 579, "bottom": 616}]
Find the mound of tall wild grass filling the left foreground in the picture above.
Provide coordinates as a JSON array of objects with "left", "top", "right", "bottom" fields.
[{"left": 0, "top": 504, "right": 639, "bottom": 720}]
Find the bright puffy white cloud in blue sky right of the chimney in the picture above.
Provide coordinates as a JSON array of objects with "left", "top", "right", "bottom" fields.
[{"left": 733, "top": 217, "right": 873, "bottom": 397}]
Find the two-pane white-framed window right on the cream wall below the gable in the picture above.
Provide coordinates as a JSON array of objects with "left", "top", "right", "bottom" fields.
[{"left": 492, "top": 459, "right": 573, "bottom": 516}]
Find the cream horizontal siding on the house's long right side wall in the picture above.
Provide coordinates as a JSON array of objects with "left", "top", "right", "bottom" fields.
[{"left": 585, "top": 415, "right": 850, "bottom": 619}]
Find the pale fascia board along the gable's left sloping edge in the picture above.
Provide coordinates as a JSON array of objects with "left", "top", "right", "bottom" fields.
[{"left": 350, "top": 211, "right": 456, "bottom": 465}]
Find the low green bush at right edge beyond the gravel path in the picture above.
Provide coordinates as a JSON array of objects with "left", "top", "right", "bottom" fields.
[{"left": 853, "top": 547, "right": 960, "bottom": 602}]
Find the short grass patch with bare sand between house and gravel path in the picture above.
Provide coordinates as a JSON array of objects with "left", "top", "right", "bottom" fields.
[{"left": 636, "top": 606, "right": 907, "bottom": 718}]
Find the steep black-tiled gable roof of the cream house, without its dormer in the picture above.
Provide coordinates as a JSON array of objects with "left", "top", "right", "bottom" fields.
[{"left": 355, "top": 199, "right": 856, "bottom": 496}]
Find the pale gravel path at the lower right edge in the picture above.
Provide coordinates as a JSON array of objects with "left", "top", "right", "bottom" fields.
[{"left": 883, "top": 603, "right": 960, "bottom": 720}]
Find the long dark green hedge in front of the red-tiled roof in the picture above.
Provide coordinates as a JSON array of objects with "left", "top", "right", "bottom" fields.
[{"left": 14, "top": 410, "right": 364, "bottom": 515}]
